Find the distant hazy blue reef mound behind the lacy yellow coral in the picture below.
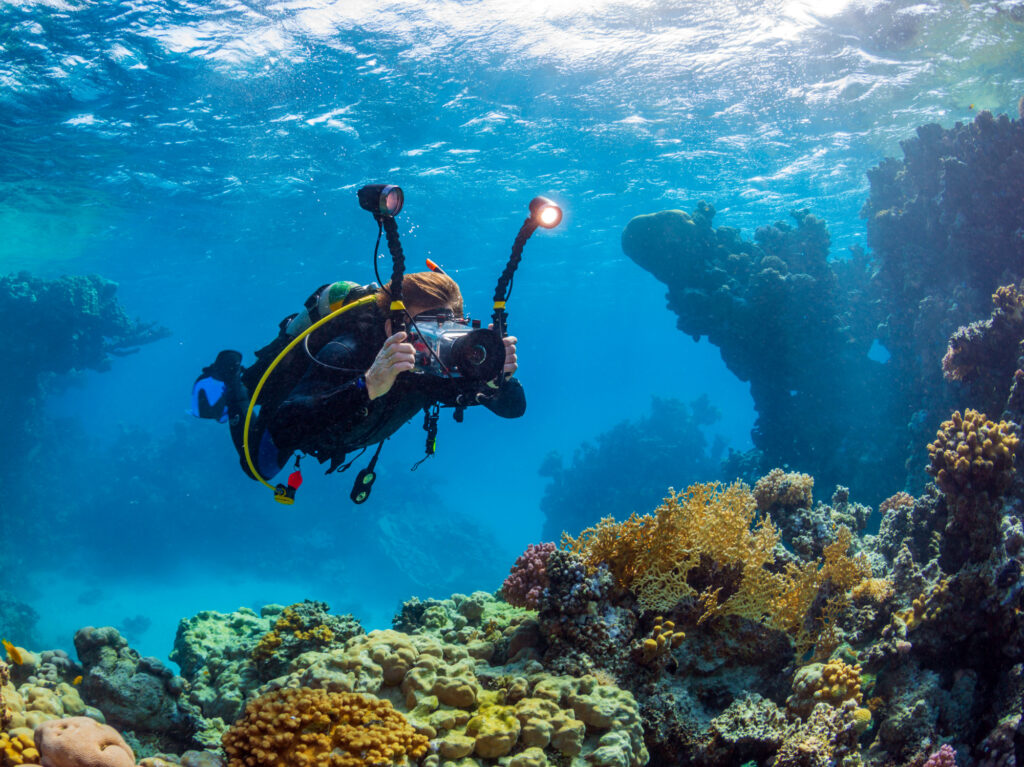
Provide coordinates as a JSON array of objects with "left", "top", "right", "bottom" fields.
[{"left": 540, "top": 396, "right": 723, "bottom": 541}]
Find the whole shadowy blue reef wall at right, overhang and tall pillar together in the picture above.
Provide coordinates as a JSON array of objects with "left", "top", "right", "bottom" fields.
[{"left": 622, "top": 107, "right": 1024, "bottom": 503}]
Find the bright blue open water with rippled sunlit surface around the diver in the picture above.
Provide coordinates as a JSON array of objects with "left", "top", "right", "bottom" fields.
[{"left": 0, "top": 0, "right": 1024, "bottom": 657}]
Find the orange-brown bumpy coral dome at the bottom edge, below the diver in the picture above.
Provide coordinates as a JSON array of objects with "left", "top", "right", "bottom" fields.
[{"left": 223, "top": 687, "right": 428, "bottom": 767}]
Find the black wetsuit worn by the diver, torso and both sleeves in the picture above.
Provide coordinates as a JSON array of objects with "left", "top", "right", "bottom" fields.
[{"left": 238, "top": 307, "right": 526, "bottom": 469}]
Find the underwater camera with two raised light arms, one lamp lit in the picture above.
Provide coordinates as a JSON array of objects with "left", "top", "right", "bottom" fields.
[{"left": 358, "top": 184, "right": 562, "bottom": 386}]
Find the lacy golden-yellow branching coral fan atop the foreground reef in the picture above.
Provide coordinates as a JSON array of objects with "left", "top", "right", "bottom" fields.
[{"left": 562, "top": 482, "right": 870, "bottom": 635}]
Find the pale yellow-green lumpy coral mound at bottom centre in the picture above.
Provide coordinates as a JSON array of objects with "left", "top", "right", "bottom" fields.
[{"left": 256, "top": 631, "right": 647, "bottom": 767}]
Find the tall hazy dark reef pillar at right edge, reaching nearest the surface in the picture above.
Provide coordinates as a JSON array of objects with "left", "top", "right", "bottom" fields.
[{"left": 860, "top": 112, "right": 1024, "bottom": 488}]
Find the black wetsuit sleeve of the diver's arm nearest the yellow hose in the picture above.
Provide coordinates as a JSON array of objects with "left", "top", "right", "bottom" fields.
[{"left": 269, "top": 343, "right": 370, "bottom": 451}]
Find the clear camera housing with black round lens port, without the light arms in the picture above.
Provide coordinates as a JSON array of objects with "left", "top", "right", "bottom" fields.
[{"left": 409, "top": 316, "right": 505, "bottom": 381}]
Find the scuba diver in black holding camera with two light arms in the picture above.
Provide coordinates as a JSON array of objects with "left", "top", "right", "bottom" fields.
[{"left": 193, "top": 184, "right": 561, "bottom": 504}]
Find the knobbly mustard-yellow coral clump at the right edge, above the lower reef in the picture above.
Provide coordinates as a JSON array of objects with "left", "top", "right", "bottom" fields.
[{"left": 928, "top": 409, "right": 1018, "bottom": 501}]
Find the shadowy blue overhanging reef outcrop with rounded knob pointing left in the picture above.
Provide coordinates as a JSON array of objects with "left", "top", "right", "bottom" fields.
[{"left": 622, "top": 202, "right": 902, "bottom": 501}]
